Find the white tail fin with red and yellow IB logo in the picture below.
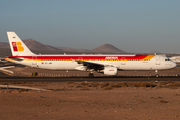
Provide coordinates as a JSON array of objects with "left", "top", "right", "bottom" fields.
[{"left": 7, "top": 32, "right": 35, "bottom": 56}]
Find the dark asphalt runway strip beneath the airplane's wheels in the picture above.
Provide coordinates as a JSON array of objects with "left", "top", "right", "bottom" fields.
[{"left": 0, "top": 76, "right": 180, "bottom": 82}]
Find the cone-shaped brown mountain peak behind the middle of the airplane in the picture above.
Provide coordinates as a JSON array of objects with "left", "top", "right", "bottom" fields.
[{"left": 91, "top": 44, "right": 125, "bottom": 53}]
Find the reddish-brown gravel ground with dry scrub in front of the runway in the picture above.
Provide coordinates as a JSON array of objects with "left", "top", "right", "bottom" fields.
[{"left": 0, "top": 81, "right": 180, "bottom": 120}]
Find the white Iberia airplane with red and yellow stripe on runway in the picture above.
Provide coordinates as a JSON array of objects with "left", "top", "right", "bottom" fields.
[{"left": 5, "top": 32, "right": 176, "bottom": 77}]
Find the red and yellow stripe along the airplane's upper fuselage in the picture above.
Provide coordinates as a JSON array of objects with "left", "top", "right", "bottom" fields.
[{"left": 5, "top": 55, "right": 155, "bottom": 61}]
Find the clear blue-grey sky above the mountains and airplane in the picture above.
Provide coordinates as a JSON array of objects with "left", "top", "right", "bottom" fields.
[{"left": 0, "top": 0, "right": 180, "bottom": 53}]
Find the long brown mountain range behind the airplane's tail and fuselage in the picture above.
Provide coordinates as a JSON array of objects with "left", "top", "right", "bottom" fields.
[{"left": 0, "top": 39, "right": 125, "bottom": 56}]
